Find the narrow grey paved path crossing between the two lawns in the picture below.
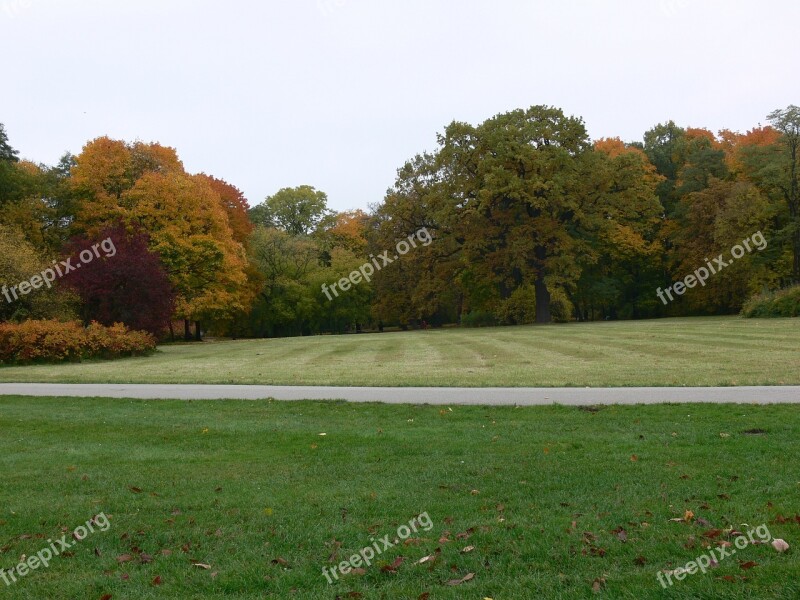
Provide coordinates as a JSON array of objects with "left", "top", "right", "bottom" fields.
[{"left": 0, "top": 383, "right": 800, "bottom": 406}]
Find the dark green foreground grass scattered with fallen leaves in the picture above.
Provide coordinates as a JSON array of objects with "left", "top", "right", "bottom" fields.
[{"left": 0, "top": 397, "right": 800, "bottom": 600}]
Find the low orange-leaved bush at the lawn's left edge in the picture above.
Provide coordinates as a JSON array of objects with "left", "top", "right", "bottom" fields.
[{"left": 0, "top": 321, "right": 156, "bottom": 365}]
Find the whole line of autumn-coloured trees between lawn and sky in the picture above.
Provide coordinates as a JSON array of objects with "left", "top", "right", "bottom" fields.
[{"left": 0, "top": 106, "right": 800, "bottom": 338}]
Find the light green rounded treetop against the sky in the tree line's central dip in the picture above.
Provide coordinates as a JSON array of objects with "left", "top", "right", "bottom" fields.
[{"left": 250, "top": 185, "right": 330, "bottom": 235}]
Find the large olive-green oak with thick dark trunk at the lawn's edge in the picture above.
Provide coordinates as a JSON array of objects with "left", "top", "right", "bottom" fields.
[{"left": 439, "top": 106, "right": 590, "bottom": 323}]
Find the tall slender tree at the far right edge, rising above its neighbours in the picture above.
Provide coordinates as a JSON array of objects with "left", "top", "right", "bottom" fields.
[{"left": 767, "top": 104, "right": 800, "bottom": 284}]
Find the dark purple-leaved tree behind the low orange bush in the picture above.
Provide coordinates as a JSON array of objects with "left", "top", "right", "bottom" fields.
[{"left": 64, "top": 226, "right": 175, "bottom": 336}]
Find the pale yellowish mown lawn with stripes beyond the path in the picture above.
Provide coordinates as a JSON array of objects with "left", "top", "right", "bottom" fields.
[{"left": 0, "top": 317, "right": 800, "bottom": 387}]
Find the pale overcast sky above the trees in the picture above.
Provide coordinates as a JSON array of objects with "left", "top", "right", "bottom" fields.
[{"left": 0, "top": 0, "right": 800, "bottom": 210}]
